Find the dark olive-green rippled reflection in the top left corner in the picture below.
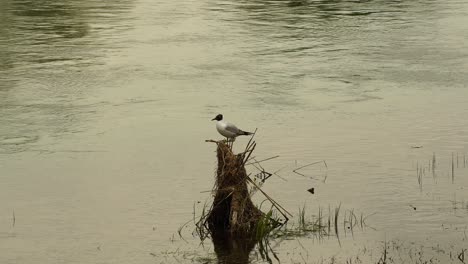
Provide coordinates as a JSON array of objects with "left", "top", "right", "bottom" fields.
[{"left": 0, "top": 0, "right": 133, "bottom": 67}]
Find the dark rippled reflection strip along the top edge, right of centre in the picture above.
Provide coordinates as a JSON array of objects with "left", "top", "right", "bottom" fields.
[{"left": 218, "top": 0, "right": 437, "bottom": 39}]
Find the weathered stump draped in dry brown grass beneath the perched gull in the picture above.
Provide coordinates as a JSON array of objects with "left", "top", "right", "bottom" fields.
[{"left": 197, "top": 134, "right": 290, "bottom": 239}]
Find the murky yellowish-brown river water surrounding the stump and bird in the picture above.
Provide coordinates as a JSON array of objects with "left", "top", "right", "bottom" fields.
[{"left": 0, "top": 0, "right": 468, "bottom": 264}]
